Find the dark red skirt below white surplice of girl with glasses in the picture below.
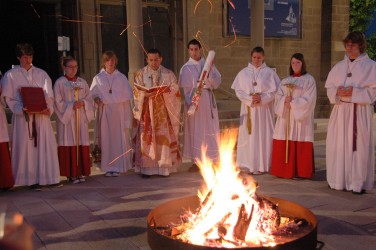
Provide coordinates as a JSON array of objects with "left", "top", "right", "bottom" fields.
[{"left": 57, "top": 145, "right": 91, "bottom": 177}]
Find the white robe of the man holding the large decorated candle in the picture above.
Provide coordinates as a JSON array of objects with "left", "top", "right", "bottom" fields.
[{"left": 179, "top": 58, "right": 222, "bottom": 161}]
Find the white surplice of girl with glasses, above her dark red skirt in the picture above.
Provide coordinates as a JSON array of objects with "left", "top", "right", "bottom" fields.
[{"left": 54, "top": 76, "right": 94, "bottom": 146}]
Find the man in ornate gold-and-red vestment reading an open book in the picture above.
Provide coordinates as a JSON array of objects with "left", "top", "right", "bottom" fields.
[{"left": 132, "top": 49, "right": 181, "bottom": 177}]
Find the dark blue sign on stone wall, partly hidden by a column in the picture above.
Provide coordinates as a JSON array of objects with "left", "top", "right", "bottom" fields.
[{"left": 227, "top": 0, "right": 301, "bottom": 38}]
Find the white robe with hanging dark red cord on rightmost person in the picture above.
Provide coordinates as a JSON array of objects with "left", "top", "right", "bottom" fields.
[{"left": 325, "top": 54, "right": 376, "bottom": 192}]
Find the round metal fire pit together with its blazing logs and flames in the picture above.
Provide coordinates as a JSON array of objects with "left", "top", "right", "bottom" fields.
[{"left": 148, "top": 130, "right": 317, "bottom": 249}]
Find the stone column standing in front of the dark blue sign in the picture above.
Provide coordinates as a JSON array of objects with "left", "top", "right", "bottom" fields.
[{"left": 251, "top": 0, "right": 264, "bottom": 49}]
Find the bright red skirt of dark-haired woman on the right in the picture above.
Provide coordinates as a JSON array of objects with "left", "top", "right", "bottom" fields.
[{"left": 270, "top": 139, "right": 315, "bottom": 179}]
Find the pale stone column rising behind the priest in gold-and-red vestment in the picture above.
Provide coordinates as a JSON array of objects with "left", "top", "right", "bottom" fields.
[{"left": 126, "top": 0, "right": 145, "bottom": 84}]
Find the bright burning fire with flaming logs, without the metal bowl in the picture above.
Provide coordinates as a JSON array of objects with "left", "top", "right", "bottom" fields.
[{"left": 172, "top": 130, "right": 281, "bottom": 247}]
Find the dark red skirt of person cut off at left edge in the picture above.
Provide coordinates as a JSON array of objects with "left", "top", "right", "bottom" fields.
[{"left": 0, "top": 142, "right": 14, "bottom": 189}]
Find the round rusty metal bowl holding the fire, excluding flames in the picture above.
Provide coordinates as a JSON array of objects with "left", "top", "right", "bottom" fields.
[{"left": 147, "top": 196, "right": 317, "bottom": 250}]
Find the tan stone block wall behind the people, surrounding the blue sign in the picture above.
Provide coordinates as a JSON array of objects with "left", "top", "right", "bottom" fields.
[{"left": 186, "top": 0, "right": 349, "bottom": 117}]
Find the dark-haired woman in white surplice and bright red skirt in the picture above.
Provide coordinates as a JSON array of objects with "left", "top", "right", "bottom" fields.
[{"left": 270, "top": 53, "right": 317, "bottom": 179}]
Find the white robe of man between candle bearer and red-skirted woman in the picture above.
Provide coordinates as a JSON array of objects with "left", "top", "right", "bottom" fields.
[{"left": 231, "top": 63, "right": 279, "bottom": 172}]
